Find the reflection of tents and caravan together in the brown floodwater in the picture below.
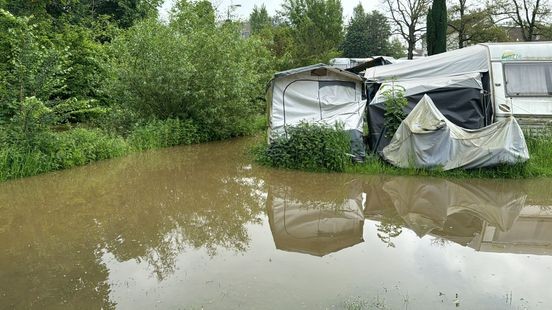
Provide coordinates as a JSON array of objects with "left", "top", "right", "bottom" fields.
[{"left": 267, "top": 175, "right": 552, "bottom": 256}]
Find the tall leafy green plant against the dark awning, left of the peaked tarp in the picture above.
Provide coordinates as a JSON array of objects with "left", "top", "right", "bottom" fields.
[{"left": 382, "top": 81, "right": 408, "bottom": 138}]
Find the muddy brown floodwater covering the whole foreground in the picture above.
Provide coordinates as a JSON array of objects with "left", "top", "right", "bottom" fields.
[{"left": 0, "top": 139, "right": 552, "bottom": 309}]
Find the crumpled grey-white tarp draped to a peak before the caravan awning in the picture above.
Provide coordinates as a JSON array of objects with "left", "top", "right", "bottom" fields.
[{"left": 383, "top": 95, "right": 529, "bottom": 170}]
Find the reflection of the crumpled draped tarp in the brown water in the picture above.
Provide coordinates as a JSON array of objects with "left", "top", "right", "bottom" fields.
[{"left": 383, "top": 177, "right": 527, "bottom": 245}]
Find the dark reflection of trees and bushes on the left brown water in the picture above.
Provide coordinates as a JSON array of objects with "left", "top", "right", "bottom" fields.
[{"left": 0, "top": 141, "right": 264, "bottom": 309}]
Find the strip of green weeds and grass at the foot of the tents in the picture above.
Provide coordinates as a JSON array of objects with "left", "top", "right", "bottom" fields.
[{"left": 254, "top": 126, "right": 552, "bottom": 179}]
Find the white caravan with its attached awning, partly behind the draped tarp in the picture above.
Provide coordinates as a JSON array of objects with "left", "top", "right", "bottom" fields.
[{"left": 365, "top": 42, "right": 552, "bottom": 147}]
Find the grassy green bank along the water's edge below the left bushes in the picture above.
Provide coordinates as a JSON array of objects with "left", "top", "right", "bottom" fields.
[{"left": 0, "top": 116, "right": 265, "bottom": 181}]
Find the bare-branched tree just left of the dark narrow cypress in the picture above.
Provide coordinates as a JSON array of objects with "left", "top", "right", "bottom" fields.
[{"left": 385, "top": 0, "right": 429, "bottom": 59}]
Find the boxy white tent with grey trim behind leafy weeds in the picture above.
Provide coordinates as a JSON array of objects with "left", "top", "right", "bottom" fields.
[{"left": 267, "top": 64, "right": 366, "bottom": 157}]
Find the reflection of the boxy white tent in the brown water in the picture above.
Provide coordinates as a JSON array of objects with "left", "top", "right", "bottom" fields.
[{"left": 268, "top": 193, "right": 364, "bottom": 256}]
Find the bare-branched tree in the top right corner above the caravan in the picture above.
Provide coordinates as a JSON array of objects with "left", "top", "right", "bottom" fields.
[{"left": 494, "top": 0, "right": 552, "bottom": 41}]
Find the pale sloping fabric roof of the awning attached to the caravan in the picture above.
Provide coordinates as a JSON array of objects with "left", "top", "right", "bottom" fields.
[{"left": 364, "top": 45, "right": 489, "bottom": 83}]
